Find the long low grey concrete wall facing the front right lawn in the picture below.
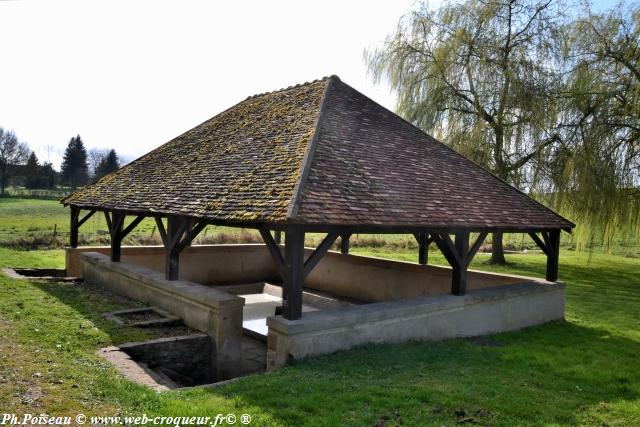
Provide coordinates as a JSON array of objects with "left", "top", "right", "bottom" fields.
[{"left": 267, "top": 282, "right": 564, "bottom": 369}]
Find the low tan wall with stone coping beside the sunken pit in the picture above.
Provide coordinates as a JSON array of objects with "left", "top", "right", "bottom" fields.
[{"left": 78, "top": 252, "right": 244, "bottom": 380}]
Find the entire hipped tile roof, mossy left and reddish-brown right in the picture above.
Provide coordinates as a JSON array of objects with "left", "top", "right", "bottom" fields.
[{"left": 63, "top": 76, "right": 573, "bottom": 229}]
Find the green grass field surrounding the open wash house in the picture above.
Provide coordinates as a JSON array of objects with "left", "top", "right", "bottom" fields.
[{"left": 0, "top": 199, "right": 640, "bottom": 426}]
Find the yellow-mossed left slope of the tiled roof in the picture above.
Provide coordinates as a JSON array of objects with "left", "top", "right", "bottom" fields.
[{"left": 63, "top": 79, "right": 327, "bottom": 221}]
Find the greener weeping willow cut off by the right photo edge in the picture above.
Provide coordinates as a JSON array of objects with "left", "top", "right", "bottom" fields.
[{"left": 537, "top": 4, "right": 640, "bottom": 250}]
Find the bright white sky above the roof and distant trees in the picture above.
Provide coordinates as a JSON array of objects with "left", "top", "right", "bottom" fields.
[{"left": 0, "top": 0, "right": 413, "bottom": 167}]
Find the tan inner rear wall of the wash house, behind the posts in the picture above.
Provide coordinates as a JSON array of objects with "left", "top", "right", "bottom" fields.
[{"left": 66, "top": 244, "right": 531, "bottom": 302}]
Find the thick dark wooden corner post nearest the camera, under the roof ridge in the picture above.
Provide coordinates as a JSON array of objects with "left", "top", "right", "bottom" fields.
[{"left": 282, "top": 226, "right": 304, "bottom": 320}]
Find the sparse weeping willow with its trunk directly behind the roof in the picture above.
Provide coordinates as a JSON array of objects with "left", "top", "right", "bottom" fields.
[{"left": 365, "top": 0, "right": 562, "bottom": 264}]
